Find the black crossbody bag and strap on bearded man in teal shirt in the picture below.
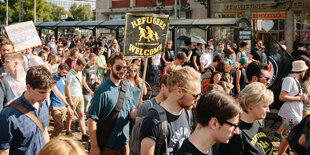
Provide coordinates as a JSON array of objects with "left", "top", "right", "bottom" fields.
[{"left": 97, "top": 79, "right": 128, "bottom": 151}]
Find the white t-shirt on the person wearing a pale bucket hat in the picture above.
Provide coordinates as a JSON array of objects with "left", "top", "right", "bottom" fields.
[{"left": 278, "top": 77, "right": 303, "bottom": 121}]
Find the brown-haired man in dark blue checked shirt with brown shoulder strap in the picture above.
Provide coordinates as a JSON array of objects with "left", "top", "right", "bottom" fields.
[{"left": 0, "top": 66, "right": 56, "bottom": 155}]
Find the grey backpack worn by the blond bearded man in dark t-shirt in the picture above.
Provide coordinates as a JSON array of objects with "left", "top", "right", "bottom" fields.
[{"left": 129, "top": 104, "right": 169, "bottom": 155}]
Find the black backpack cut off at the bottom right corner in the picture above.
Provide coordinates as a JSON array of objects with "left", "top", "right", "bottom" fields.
[{"left": 287, "top": 115, "right": 310, "bottom": 154}]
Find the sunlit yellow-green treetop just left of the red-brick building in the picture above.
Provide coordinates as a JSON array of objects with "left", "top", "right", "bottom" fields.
[{"left": 69, "top": 3, "right": 93, "bottom": 21}]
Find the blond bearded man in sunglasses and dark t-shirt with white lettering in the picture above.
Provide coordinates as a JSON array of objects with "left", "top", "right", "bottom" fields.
[{"left": 139, "top": 66, "right": 201, "bottom": 155}]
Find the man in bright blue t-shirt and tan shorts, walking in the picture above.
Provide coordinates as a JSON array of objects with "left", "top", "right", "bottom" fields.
[{"left": 51, "top": 63, "right": 73, "bottom": 138}]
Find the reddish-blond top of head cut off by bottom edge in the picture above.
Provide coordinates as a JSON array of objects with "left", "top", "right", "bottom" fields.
[{"left": 38, "top": 136, "right": 86, "bottom": 155}]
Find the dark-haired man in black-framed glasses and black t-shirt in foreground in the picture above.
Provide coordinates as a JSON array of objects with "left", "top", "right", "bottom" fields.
[{"left": 176, "top": 91, "right": 241, "bottom": 155}]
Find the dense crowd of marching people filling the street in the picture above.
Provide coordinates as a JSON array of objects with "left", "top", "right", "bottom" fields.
[{"left": 0, "top": 32, "right": 310, "bottom": 155}]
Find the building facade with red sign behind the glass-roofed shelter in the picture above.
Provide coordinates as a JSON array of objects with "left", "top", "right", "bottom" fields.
[{"left": 96, "top": 0, "right": 310, "bottom": 52}]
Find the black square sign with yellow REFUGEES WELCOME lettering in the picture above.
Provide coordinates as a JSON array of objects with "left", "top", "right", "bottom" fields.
[{"left": 123, "top": 13, "right": 169, "bottom": 58}]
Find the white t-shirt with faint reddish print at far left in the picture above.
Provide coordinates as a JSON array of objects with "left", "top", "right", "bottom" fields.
[{"left": 3, "top": 73, "right": 27, "bottom": 102}]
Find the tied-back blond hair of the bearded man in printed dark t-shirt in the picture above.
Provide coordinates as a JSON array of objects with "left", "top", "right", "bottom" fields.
[{"left": 166, "top": 66, "right": 201, "bottom": 92}]
